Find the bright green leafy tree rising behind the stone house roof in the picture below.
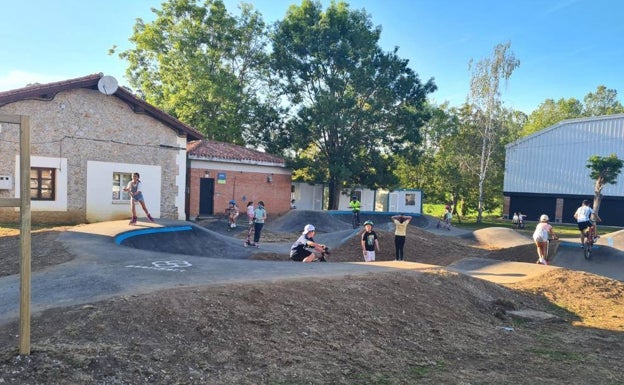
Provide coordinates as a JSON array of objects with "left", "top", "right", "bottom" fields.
[{"left": 117, "top": 0, "right": 276, "bottom": 144}]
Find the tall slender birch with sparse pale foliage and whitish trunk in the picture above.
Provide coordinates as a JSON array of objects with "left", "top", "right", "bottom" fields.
[{"left": 470, "top": 43, "right": 520, "bottom": 223}]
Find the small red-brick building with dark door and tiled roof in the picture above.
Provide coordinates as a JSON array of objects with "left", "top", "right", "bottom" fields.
[{"left": 187, "top": 140, "right": 292, "bottom": 219}]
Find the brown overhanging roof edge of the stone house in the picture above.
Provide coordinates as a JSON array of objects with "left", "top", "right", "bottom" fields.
[{"left": 0, "top": 73, "right": 204, "bottom": 140}]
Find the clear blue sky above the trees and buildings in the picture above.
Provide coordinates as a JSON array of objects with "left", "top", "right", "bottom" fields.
[{"left": 0, "top": 0, "right": 624, "bottom": 113}]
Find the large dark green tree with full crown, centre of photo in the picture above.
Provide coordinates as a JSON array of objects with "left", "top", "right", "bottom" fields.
[{"left": 272, "top": 0, "right": 436, "bottom": 209}]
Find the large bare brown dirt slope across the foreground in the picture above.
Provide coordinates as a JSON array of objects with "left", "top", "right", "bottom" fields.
[{"left": 0, "top": 271, "right": 624, "bottom": 385}]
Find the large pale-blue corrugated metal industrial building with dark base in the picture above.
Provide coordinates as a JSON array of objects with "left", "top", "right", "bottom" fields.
[{"left": 503, "top": 114, "right": 624, "bottom": 226}]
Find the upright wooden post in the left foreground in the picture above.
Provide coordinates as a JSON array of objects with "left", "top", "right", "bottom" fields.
[{"left": 19, "top": 116, "right": 32, "bottom": 355}]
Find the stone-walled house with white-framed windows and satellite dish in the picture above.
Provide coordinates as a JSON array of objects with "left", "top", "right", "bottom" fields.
[{"left": 0, "top": 74, "right": 203, "bottom": 223}]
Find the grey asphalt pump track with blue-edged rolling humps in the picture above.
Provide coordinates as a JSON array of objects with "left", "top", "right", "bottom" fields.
[{"left": 0, "top": 210, "right": 624, "bottom": 323}]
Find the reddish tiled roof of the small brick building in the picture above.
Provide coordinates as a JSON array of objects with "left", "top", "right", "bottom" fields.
[{"left": 186, "top": 140, "right": 286, "bottom": 167}]
